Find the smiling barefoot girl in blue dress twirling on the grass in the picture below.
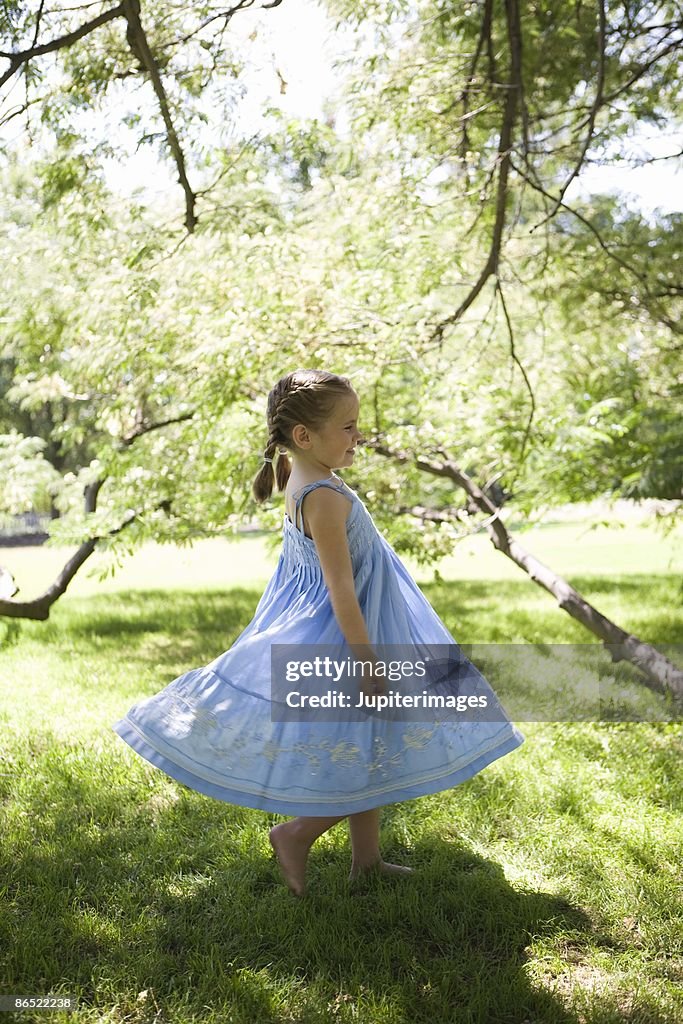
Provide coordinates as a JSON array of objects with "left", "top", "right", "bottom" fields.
[{"left": 114, "top": 370, "right": 524, "bottom": 896}]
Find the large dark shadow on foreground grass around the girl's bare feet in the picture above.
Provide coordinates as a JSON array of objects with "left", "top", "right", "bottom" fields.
[{"left": 0, "top": 735, "right": 671, "bottom": 1024}]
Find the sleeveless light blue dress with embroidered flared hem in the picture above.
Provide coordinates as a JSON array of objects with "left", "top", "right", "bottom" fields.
[{"left": 113, "top": 474, "right": 524, "bottom": 815}]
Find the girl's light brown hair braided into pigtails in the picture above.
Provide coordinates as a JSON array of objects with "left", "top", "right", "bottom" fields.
[{"left": 252, "top": 370, "right": 354, "bottom": 503}]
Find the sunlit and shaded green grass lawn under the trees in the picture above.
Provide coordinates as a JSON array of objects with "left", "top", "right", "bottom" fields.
[{"left": 0, "top": 524, "right": 683, "bottom": 1024}]
